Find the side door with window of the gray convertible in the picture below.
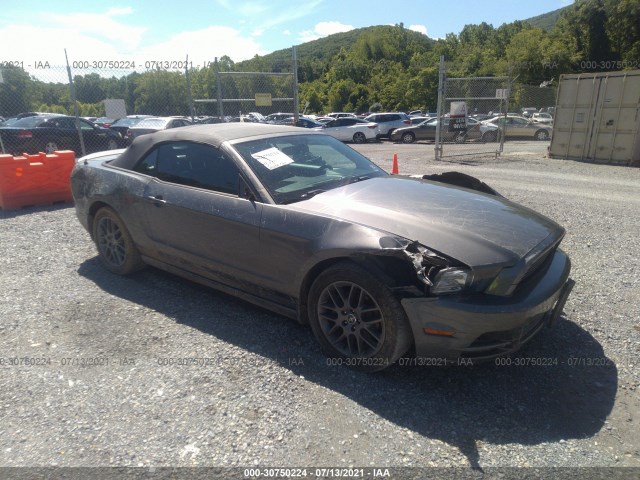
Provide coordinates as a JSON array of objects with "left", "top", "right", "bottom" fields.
[{"left": 135, "top": 141, "right": 262, "bottom": 291}]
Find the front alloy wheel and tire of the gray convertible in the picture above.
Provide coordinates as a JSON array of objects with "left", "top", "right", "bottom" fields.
[{"left": 308, "top": 262, "right": 413, "bottom": 372}]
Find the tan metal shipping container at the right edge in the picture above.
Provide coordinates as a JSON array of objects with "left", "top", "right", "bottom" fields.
[{"left": 549, "top": 70, "right": 640, "bottom": 166}]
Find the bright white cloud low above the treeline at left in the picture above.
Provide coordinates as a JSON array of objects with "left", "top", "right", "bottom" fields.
[{"left": 0, "top": 12, "right": 267, "bottom": 83}]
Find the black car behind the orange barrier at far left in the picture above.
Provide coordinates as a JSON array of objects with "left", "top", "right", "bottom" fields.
[{"left": 0, "top": 114, "right": 124, "bottom": 155}]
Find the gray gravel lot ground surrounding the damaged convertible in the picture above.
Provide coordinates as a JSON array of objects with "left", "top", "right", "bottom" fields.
[{"left": 0, "top": 142, "right": 640, "bottom": 477}]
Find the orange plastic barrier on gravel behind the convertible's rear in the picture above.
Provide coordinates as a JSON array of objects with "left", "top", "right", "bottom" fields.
[{"left": 0, "top": 150, "right": 76, "bottom": 210}]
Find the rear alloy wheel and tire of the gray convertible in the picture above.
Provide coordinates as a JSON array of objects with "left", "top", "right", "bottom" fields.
[{"left": 93, "top": 207, "right": 144, "bottom": 275}]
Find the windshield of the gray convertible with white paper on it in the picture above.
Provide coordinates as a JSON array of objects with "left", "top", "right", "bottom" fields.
[{"left": 233, "top": 135, "right": 387, "bottom": 204}]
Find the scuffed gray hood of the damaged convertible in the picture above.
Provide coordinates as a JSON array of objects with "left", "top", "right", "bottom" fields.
[{"left": 288, "top": 176, "right": 564, "bottom": 267}]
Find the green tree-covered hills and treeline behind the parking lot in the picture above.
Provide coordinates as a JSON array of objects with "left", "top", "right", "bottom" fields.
[{"left": 0, "top": 0, "right": 640, "bottom": 116}]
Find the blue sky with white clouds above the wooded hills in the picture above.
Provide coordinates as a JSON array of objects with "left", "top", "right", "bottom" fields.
[{"left": 0, "top": 0, "right": 572, "bottom": 66}]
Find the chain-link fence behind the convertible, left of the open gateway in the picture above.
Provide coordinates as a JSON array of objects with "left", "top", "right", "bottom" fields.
[{"left": 0, "top": 51, "right": 298, "bottom": 156}]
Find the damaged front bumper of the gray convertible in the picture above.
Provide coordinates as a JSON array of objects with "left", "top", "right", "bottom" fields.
[{"left": 402, "top": 249, "right": 574, "bottom": 362}]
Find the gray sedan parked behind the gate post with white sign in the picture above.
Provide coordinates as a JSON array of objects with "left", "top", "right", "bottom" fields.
[{"left": 390, "top": 117, "right": 498, "bottom": 143}]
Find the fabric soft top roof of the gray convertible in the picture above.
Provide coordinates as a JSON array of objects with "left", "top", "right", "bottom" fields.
[{"left": 111, "top": 122, "right": 313, "bottom": 170}]
